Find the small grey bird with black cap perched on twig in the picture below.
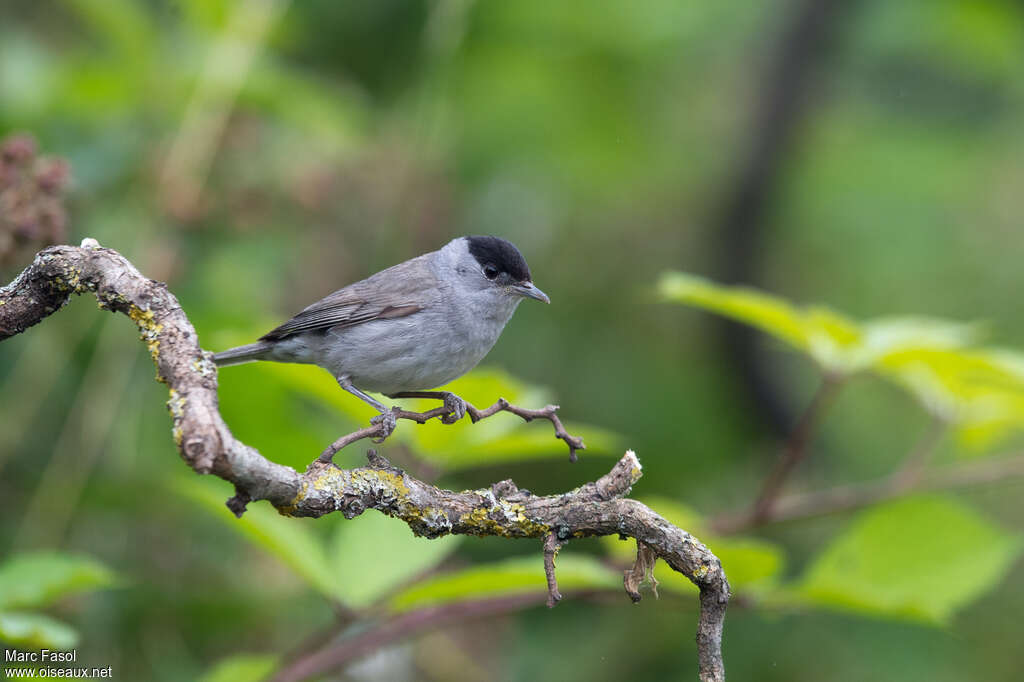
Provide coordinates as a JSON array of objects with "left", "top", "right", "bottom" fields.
[{"left": 213, "top": 236, "right": 551, "bottom": 431}]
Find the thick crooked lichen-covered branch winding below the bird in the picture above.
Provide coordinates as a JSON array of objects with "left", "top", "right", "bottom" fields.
[{"left": 0, "top": 240, "right": 729, "bottom": 681}]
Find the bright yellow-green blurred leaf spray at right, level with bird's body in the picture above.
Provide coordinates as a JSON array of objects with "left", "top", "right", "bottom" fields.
[{"left": 658, "top": 272, "right": 1024, "bottom": 451}]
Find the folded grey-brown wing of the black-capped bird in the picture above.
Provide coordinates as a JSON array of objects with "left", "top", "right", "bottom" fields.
[{"left": 260, "top": 256, "right": 440, "bottom": 341}]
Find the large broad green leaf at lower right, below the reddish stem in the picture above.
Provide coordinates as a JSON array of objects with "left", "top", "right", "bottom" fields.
[{"left": 796, "top": 497, "right": 1021, "bottom": 624}]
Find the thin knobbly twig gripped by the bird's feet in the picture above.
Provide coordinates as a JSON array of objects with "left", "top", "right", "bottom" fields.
[{"left": 317, "top": 391, "right": 587, "bottom": 463}]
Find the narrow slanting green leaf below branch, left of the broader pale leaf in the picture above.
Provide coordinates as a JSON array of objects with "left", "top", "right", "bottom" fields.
[{"left": 174, "top": 477, "right": 341, "bottom": 599}]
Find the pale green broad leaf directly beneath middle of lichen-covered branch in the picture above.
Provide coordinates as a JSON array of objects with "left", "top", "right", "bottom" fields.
[{"left": 331, "top": 512, "right": 462, "bottom": 606}]
